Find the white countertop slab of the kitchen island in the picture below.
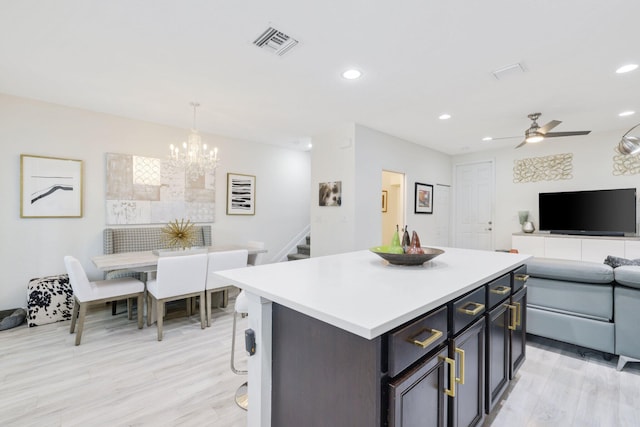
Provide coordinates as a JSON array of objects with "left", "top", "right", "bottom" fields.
[{"left": 218, "top": 247, "right": 530, "bottom": 339}]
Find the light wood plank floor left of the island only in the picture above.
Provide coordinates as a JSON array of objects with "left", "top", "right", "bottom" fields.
[{"left": 0, "top": 292, "right": 247, "bottom": 427}]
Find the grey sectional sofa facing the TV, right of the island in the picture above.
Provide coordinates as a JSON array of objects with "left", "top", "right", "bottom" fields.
[{"left": 527, "top": 257, "right": 640, "bottom": 370}]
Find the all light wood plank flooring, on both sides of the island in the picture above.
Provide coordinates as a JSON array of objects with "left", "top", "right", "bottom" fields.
[{"left": 0, "top": 295, "right": 640, "bottom": 427}]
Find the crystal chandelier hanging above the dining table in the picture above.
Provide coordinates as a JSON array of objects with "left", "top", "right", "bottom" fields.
[{"left": 169, "top": 102, "right": 218, "bottom": 181}]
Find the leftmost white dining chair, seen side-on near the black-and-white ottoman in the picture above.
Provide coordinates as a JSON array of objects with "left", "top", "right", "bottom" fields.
[{"left": 64, "top": 255, "right": 144, "bottom": 345}]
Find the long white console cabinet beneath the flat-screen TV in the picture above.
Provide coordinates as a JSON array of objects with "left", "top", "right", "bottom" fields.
[{"left": 511, "top": 233, "right": 640, "bottom": 262}]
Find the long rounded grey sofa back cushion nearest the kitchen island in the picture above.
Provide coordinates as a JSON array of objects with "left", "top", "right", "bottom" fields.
[{"left": 526, "top": 257, "right": 613, "bottom": 284}]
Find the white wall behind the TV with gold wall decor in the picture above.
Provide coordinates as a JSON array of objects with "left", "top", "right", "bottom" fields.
[{"left": 453, "top": 129, "right": 640, "bottom": 249}]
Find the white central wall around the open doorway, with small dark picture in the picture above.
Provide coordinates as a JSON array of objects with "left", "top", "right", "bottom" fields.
[{"left": 311, "top": 125, "right": 452, "bottom": 256}]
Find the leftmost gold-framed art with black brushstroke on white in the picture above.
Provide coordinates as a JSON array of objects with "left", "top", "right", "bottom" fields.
[{"left": 20, "top": 154, "right": 82, "bottom": 218}]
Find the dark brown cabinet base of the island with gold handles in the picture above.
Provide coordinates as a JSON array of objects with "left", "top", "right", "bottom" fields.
[{"left": 271, "top": 264, "right": 526, "bottom": 427}]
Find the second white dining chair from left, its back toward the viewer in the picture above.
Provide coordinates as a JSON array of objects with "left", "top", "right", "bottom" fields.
[{"left": 147, "top": 253, "right": 207, "bottom": 341}]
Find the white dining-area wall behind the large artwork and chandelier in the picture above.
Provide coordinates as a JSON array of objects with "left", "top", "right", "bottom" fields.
[{"left": 0, "top": 94, "right": 310, "bottom": 309}]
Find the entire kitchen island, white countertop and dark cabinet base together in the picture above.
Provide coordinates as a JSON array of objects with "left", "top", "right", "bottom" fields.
[{"left": 219, "top": 247, "right": 529, "bottom": 427}]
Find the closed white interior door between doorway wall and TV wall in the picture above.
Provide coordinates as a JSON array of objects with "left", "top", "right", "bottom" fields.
[{"left": 455, "top": 161, "right": 494, "bottom": 250}]
